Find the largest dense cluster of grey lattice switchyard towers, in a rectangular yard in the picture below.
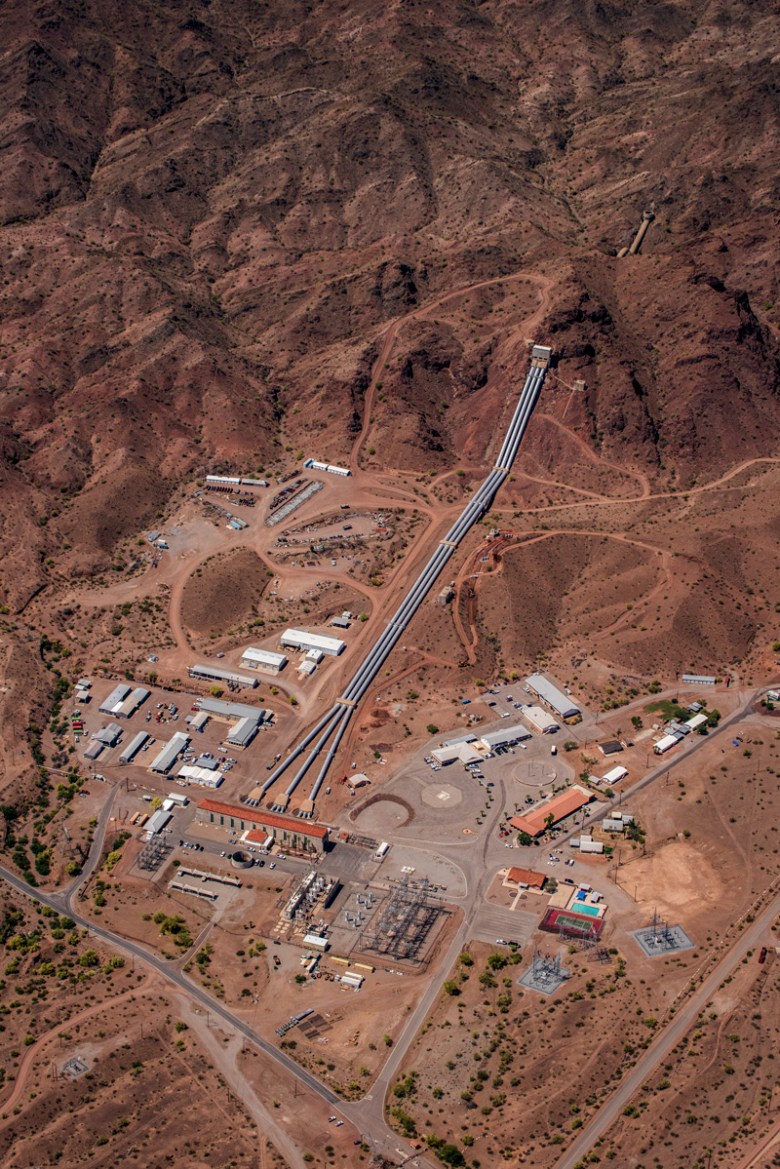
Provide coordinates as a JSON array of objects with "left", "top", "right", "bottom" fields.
[{"left": 360, "top": 876, "right": 446, "bottom": 962}]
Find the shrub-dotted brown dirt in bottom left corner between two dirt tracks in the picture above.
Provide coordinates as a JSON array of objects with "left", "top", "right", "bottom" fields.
[{"left": 0, "top": 994, "right": 266, "bottom": 1169}]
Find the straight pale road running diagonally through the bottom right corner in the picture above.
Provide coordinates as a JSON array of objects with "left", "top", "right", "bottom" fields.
[{"left": 554, "top": 894, "right": 780, "bottom": 1169}]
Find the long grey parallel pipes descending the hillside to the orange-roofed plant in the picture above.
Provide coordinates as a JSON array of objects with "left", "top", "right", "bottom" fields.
[{"left": 262, "top": 345, "right": 552, "bottom": 811}]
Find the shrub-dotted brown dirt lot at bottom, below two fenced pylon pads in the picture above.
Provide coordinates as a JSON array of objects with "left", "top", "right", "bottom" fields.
[{"left": 389, "top": 938, "right": 682, "bottom": 1169}]
